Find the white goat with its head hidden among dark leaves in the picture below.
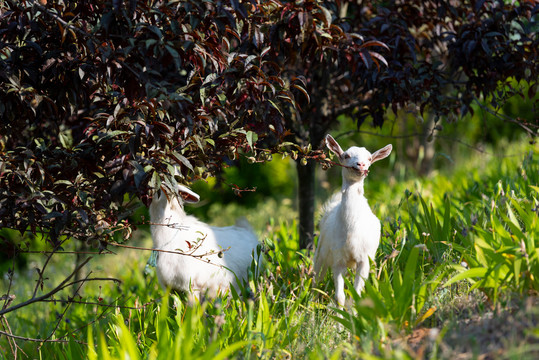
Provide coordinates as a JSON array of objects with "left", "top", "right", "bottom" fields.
[{"left": 150, "top": 185, "right": 260, "bottom": 300}]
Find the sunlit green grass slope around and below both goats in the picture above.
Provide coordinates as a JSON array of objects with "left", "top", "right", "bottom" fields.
[{"left": 0, "top": 139, "right": 539, "bottom": 359}]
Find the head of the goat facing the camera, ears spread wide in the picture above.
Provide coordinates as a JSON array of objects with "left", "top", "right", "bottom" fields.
[{"left": 326, "top": 134, "right": 393, "bottom": 182}]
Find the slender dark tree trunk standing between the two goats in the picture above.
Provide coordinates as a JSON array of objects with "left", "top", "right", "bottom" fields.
[{"left": 296, "top": 160, "right": 317, "bottom": 250}]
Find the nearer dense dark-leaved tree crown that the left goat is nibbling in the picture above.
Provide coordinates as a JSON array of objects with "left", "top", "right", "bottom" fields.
[{"left": 0, "top": 1, "right": 312, "bottom": 247}]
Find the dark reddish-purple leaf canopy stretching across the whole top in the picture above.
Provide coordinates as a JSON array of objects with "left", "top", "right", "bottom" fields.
[{"left": 0, "top": 0, "right": 537, "bottom": 253}]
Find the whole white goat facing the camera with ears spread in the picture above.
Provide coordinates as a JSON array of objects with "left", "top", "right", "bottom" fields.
[{"left": 314, "top": 134, "right": 392, "bottom": 307}]
